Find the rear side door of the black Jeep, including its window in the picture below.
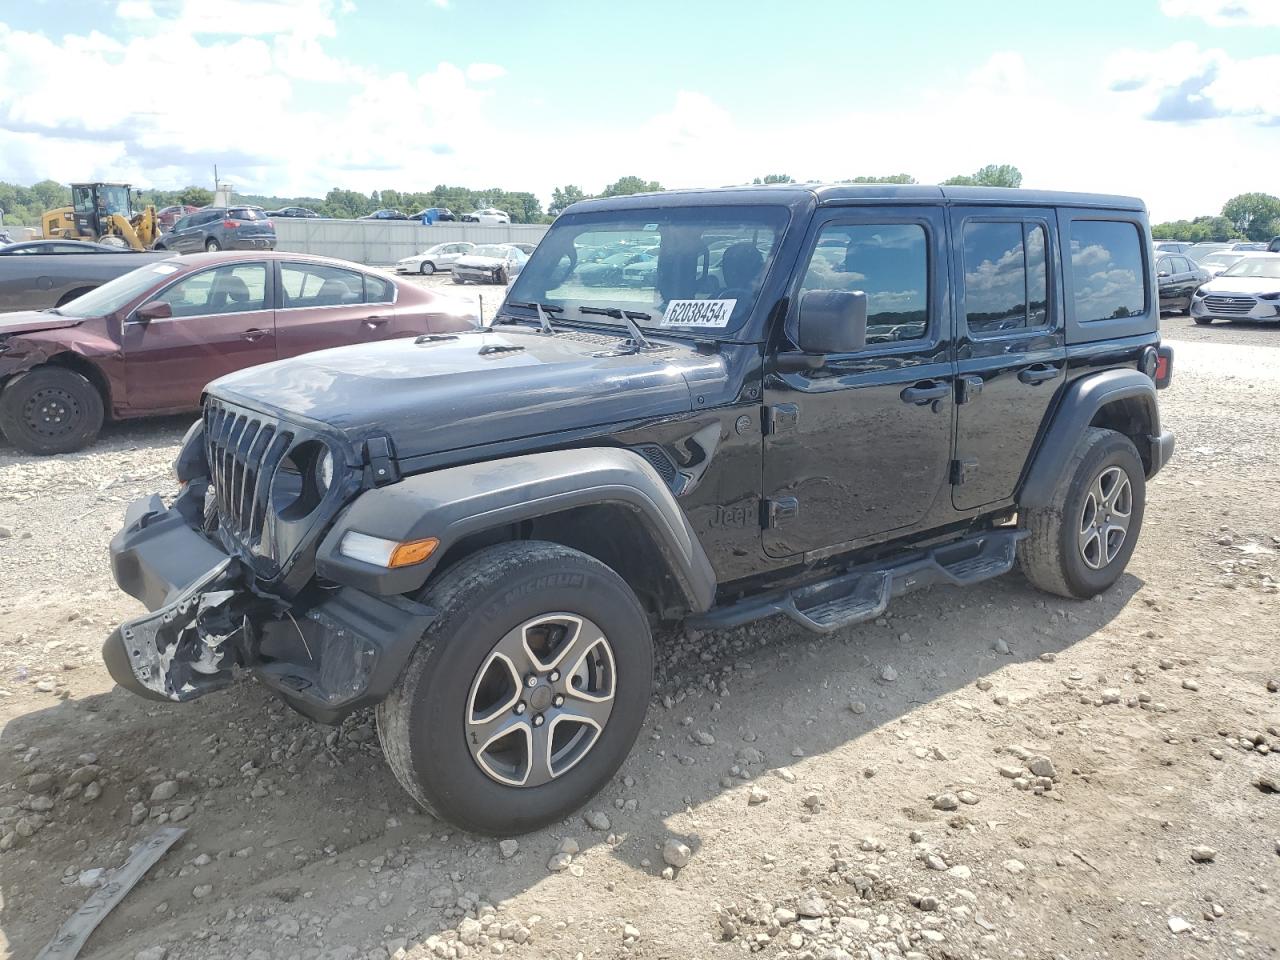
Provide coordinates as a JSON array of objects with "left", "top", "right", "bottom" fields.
[{"left": 951, "top": 207, "right": 1066, "bottom": 509}]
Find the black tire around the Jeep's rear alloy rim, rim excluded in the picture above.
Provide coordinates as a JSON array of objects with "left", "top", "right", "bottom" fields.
[{"left": 1059, "top": 434, "right": 1147, "bottom": 596}]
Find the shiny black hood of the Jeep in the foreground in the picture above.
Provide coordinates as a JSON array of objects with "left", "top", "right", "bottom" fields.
[{"left": 207, "top": 326, "right": 726, "bottom": 458}]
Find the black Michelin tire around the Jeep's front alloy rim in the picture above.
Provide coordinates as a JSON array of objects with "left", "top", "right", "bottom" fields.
[{"left": 410, "top": 554, "right": 653, "bottom": 833}]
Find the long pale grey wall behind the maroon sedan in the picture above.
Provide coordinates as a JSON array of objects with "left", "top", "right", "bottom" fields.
[{"left": 274, "top": 216, "right": 547, "bottom": 265}]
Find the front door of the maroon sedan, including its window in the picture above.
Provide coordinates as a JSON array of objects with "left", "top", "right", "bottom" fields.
[{"left": 123, "top": 261, "right": 275, "bottom": 412}]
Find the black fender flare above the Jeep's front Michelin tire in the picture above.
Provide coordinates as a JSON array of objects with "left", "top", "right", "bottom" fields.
[{"left": 316, "top": 447, "right": 716, "bottom": 612}]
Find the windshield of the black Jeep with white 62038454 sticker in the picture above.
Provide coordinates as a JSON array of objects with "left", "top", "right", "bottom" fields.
[{"left": 509, "top": 205, "right": 787, "bottom": 333}]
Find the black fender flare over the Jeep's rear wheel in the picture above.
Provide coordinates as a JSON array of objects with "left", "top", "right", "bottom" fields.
[{"left": 1018, "top": 369, "right": 1171, "bottom": 509}]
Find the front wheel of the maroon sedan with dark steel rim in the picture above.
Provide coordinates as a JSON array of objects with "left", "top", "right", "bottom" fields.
[{"left": 0, "top": 366, "right": 105, "bottom": 454}]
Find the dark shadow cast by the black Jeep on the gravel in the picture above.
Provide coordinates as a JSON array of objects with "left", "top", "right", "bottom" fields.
[{"left": 0, "top": 575, "right": 1143, "bottom": 957}]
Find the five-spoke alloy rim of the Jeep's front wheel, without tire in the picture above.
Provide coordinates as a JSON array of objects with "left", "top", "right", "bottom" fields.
[{"left": 466, "top": 613, "right": 617, "bottom": 787}]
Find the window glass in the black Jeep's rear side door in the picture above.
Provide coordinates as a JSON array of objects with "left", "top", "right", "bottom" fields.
[{"left": 964, "top": 220, "right": 1048, "bottom": 335}]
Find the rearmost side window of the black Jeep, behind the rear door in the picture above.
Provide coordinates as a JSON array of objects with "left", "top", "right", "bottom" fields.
[{"left": 1071, "top": 220, "right": 1147, "bottom": 324}]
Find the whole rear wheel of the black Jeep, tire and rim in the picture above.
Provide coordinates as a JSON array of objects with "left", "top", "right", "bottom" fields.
[{"left": 1018, "top": 426, "right": 1147, "bottom": 599}]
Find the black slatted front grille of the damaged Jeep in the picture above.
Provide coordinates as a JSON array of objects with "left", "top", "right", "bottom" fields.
[{"left": 205, "top": 397, "right": 293, "bottom": 549}]
